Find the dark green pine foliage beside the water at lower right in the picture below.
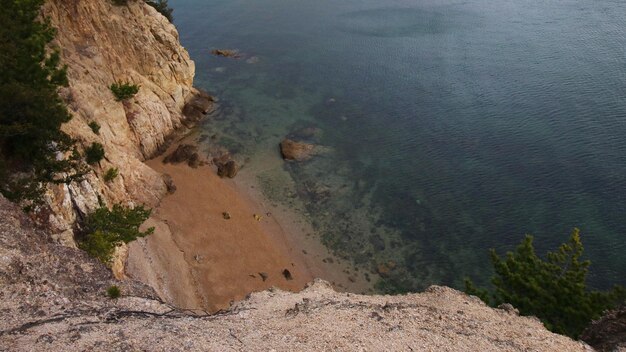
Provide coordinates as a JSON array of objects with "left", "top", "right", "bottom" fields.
[{"left": 466, "top": 229, "right": 626, "bottom": 338}]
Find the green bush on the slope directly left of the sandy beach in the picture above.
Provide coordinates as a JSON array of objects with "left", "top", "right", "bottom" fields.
[{"left": 78, "top": 204, "right": 154, "bottom": 264}]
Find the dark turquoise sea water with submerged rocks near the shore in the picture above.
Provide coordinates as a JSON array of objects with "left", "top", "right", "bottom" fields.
[{"left": 170, "top": 0, "right": 626, "bottom": 289}]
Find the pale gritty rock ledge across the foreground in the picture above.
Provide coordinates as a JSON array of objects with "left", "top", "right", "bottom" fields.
[{"left": 0, "top": 196, "right": 591, "bottom": 351}]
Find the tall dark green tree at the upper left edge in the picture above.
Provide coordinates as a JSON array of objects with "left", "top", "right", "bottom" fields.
[{"left": 0, "top": 0, "right": 87, "bottom": 204}]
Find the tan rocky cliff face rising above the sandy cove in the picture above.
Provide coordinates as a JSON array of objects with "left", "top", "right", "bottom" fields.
[{"left": 39, "top": 0, "right": 208, "bottom": 246}]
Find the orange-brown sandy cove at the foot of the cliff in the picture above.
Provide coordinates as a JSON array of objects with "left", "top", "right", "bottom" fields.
[{"left": 125, "top": 142, "right": 370, "bottom": 312}]
